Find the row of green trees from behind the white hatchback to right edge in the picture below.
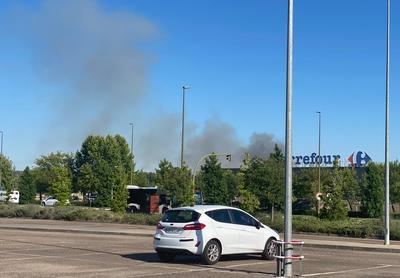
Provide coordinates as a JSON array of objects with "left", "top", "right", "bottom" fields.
[{"left": 156, "top": 143, "right": 400, "bottom": 220}]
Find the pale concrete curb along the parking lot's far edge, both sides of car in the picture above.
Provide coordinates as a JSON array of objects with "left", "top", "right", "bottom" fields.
[{"left": 0, "top": 226, "right": 400, "bottom": 253}]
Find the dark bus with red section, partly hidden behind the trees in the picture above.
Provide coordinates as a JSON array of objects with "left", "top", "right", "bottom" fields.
[{"left": 127, "top": 185, "right": 171, "bottom": 213}]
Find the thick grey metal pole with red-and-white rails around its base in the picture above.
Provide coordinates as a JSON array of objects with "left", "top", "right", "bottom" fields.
[{"left": 285, "top": 0, "right": 293, "bottom": 277}]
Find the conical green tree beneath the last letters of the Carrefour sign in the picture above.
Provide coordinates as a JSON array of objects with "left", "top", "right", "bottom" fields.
[{"left": 320, "top": 165, "right": 348, "bottom": 220}]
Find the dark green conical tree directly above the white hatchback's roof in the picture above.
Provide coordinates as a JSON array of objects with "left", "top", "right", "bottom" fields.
[{"left": 201, "top": 155, "right": 229, "bottom": 205}]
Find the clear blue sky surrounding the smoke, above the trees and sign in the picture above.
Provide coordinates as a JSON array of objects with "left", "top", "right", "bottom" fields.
[{"left": 0, "top": 0, "right": 400, "bottom": 170}]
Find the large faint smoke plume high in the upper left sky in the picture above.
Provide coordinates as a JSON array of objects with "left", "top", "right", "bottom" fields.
[{"left": 0, "top": 0, "right": 157, "bottom": 148}]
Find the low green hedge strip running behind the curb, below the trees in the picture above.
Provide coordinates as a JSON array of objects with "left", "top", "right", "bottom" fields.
[{"left": 0, "top": 204, "right": 400, "bottom": 240}]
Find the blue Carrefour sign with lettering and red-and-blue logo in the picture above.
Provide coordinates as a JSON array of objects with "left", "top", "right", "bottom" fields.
[{"left": 292, "top": 151, "right": 371, "bottom": 167}]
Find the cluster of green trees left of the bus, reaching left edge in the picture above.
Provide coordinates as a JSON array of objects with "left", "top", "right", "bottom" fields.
[{"left": 0, "top": 135, "right": 134, "bottom": 211}]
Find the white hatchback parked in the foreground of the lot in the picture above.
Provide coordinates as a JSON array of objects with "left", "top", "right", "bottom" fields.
[{"left": 153, "top": 206, "right": 279, "bottom": 264}]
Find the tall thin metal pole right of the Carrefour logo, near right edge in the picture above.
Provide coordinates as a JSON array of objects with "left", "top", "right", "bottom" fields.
[{"left": 385, "top": 0, "right": 390, "bottom": 245}]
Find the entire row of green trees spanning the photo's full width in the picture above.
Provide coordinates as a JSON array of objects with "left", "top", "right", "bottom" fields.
[{"left": 0, "top": 135, "right": 400, "bottom": 219}]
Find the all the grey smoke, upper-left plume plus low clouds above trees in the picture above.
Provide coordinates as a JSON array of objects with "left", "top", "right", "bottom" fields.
[{"left": 0, "top": 0, "right": 277, "bottom": 171}]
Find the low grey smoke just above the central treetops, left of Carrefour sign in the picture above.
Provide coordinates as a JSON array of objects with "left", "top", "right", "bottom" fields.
[{"left": 134, "top": 114, "right": 282, "bottom": 171}]
